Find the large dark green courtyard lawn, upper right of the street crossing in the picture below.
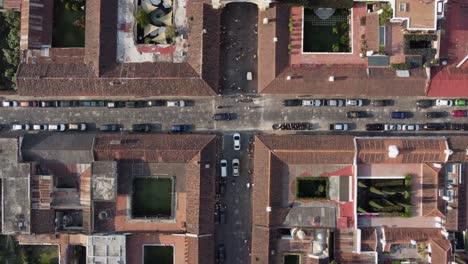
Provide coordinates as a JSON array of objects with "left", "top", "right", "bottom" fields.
[{"left": 302, "top": 8, "right": 351, "bottom": 52}]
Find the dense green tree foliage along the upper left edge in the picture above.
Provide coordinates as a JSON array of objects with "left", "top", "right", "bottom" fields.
[{"left": 0, "top": 10, "right": 21, "bottom": 89}]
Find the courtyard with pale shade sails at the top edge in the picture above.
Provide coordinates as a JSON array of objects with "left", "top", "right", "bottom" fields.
[{"left": 135, "top": 0, "right": 176, "bottom": 44}]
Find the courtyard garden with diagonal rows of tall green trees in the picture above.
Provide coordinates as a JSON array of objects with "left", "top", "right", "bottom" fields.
[{"left": 358, "top": 175, "right": 412, "bottom": 217}]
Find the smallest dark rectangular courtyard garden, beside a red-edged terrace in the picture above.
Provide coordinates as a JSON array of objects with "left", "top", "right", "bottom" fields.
[{"left": 296, "top": 177, "right": 329, "bottom": 200}]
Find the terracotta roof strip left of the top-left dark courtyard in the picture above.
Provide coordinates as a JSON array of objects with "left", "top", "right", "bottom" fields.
[{"left": 20, "top": 0, "right": 53, "bottom": 50}]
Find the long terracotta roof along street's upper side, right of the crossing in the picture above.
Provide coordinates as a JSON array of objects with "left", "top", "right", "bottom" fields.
[{"left": 260, "top": 65, "right": 427, "bottom": 96}]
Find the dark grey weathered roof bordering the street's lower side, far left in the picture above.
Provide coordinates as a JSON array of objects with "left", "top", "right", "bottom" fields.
[{"left": 21, "top": 134, "right": 94, "bottom": 164}]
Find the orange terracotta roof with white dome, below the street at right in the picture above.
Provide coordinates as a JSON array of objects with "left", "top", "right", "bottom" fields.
[{"left": 356, "top": 138, "right": 446, "bottom": 164}]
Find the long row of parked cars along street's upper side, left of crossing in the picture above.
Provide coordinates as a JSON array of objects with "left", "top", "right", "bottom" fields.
[{"left": 2, "top": 100, "right": 193, "bottom": 108}]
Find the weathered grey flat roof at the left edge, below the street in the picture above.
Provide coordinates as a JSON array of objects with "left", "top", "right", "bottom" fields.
[{"left": 0, "top": 138, "right": 31, "bottom": 234}]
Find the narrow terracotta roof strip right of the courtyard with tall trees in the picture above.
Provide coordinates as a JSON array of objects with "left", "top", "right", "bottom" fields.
[{"left": 422, "top": 164, "right": 445, "bottom": 217}]
